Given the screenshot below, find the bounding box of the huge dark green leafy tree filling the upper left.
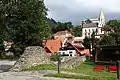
[0,0,51,57]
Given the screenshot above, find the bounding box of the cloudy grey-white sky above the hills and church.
[44,0,120,25]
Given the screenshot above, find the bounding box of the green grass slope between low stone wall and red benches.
[63,62,116,77]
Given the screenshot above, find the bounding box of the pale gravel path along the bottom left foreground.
[0,71,84,80]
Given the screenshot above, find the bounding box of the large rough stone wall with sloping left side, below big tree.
[10,46,51,71]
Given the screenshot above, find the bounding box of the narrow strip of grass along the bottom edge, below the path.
[44,74,116,80]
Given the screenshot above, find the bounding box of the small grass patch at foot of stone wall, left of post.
[26,64,56,71]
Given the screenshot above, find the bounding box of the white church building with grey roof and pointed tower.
[82,9,105,38]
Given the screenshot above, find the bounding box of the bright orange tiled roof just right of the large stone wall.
[45,40,61,53]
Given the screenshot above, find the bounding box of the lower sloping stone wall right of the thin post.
[61,56,86,69]
